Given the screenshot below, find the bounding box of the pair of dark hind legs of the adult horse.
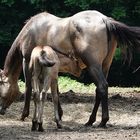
[86,64,109,127]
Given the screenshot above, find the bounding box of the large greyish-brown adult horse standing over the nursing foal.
[2,10,140,127]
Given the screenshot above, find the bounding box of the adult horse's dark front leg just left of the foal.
[21,58,32,121]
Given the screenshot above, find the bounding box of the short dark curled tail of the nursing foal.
[39,50,55,67]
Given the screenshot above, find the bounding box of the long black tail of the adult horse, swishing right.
[104,18,140,62]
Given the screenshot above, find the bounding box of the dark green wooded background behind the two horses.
[0,0,140,86]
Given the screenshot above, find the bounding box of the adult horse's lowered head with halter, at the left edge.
[0,69,18,115]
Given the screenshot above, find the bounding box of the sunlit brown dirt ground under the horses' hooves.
[0,91,140,140]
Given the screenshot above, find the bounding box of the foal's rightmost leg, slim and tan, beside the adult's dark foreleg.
[51,78,62,128]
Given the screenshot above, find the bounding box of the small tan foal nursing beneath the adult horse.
[29,46,84,131]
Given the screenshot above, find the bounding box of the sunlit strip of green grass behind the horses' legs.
[18,76,140,94]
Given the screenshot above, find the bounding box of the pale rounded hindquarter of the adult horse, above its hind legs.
[70,11,108,65]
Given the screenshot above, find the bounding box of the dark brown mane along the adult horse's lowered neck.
[4,12,47,75]
